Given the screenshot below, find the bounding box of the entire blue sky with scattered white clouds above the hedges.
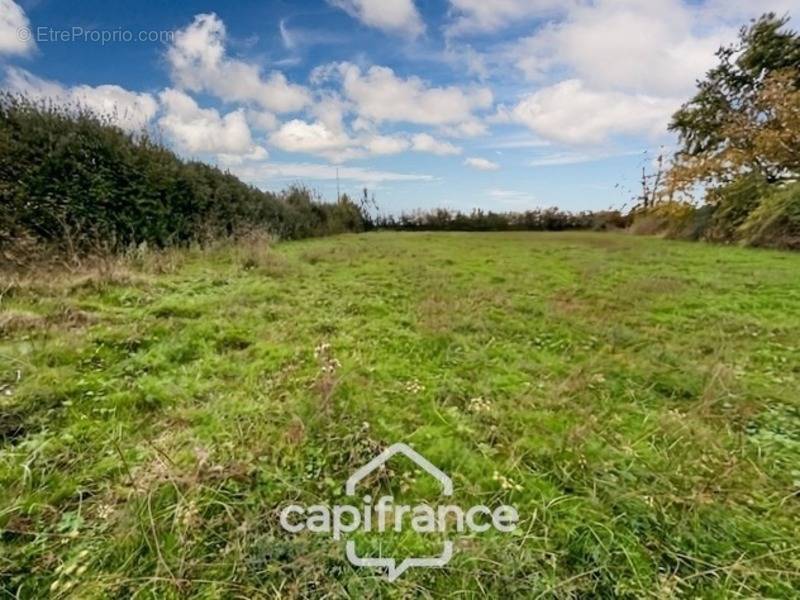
[0,0,800,212]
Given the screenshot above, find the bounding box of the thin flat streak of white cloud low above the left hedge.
[231,163,434,185]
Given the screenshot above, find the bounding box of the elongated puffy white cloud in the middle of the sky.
[332,63,493,126]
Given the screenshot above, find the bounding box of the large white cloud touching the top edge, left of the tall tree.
[510,0,736,95]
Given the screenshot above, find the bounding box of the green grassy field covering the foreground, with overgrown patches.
[0,233,800,598]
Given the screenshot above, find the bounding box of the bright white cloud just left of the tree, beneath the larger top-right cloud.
[507,79,681,144]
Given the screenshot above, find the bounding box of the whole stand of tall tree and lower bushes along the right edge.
[633,14,800,249]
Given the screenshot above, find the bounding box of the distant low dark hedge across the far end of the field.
[375,208,630,231]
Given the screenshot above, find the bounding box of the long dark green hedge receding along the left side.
[0,94,369,262]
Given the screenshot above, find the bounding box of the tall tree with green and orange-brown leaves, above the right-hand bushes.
[670,13,800,190]
